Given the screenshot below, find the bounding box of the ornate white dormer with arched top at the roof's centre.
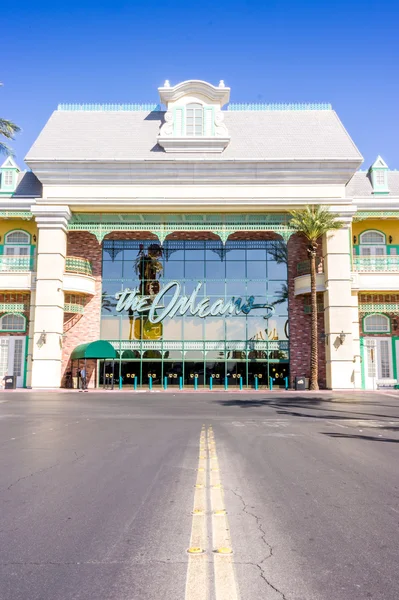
[158,79,230,152]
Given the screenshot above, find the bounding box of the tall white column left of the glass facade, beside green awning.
[31,205,71,388]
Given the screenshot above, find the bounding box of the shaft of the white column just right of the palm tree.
[323,227,358,390]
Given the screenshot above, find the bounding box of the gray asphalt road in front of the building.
[0,392,399,600]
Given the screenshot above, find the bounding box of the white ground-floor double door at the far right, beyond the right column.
[364,337,393,390]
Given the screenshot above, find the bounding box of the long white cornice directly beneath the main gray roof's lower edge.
[28,159,359,185]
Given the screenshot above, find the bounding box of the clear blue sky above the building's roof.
[0,0,399,169]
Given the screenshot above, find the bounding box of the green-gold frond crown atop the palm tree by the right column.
[289,205,344,243]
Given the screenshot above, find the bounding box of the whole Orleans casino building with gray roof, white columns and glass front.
[0,80,399,389]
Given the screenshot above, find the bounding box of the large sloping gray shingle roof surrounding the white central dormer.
[26,110,362,163]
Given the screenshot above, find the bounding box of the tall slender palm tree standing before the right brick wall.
[289,206,344,390]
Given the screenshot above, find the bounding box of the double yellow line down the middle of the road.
[185,425,239,600]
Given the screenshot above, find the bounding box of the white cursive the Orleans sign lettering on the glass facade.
[115,281,274,323]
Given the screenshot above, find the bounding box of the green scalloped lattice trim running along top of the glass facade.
[68,213,293,244]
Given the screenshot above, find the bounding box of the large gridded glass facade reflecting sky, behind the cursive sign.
[99,240,289,387]
